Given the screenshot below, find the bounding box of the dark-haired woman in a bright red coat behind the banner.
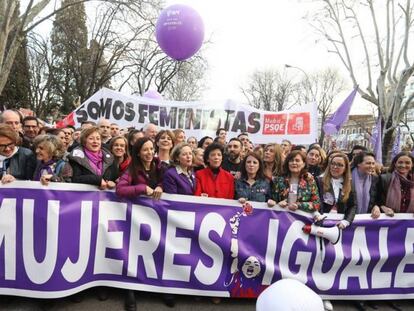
[194,143,234,199]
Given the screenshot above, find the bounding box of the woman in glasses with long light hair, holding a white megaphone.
[318,152,356,229]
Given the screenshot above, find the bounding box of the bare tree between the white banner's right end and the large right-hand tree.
[298,68,346,146]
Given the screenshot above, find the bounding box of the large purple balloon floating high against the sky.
[156,4,204,60]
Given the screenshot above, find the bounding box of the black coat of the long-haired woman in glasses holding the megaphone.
[317,177,357,223]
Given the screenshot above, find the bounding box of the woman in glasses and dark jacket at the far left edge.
[0,124,36,184]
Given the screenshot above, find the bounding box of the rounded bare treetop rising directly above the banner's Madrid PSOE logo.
[240,69,297,111]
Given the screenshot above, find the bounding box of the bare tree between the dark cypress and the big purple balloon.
[79,1,161,100]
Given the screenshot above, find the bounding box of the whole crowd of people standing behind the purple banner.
[0,110,414,310]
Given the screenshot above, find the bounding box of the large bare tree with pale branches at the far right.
[312,0,414,161]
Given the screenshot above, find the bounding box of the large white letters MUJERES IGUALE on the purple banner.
[0,198,414,290]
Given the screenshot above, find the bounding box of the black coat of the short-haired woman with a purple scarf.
[68,147,119,187]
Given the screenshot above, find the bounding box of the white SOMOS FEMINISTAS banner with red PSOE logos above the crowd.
[60,88,317,144]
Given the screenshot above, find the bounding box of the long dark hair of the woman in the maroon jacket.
[128,137,161,182]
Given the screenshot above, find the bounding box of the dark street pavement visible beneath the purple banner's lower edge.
[0,289,414,311]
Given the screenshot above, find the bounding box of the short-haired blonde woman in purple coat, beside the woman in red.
[162,143,196,195]
